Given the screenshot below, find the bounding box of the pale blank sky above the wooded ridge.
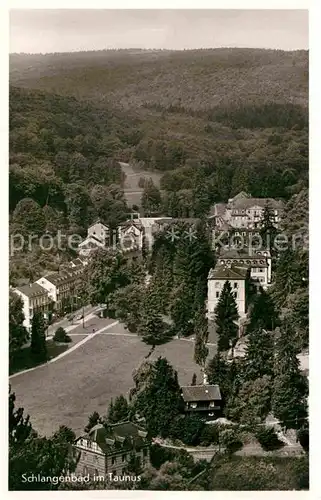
[10,9,308,53]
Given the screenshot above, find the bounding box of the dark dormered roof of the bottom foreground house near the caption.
[76,422,149,454]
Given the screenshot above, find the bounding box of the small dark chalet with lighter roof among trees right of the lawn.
[181,384,222,419]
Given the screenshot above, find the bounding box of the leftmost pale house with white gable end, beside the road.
[12,283,53,330]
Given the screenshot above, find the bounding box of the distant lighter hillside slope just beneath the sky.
[10,49,308,111]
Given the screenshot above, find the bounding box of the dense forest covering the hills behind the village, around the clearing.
[9,49,308,286]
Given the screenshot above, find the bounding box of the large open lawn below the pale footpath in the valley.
[10,325,213,435]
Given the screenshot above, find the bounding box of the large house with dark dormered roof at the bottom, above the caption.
[74,422,151,476]
